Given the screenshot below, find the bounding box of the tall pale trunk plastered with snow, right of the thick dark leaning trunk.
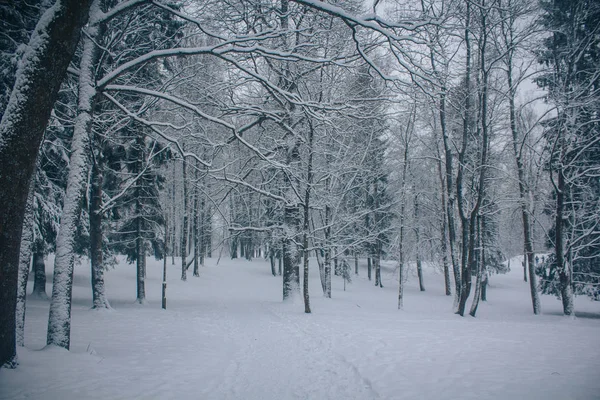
[47,0,99,349]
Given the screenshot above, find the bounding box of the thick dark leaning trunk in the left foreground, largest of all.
[0,0,91,367]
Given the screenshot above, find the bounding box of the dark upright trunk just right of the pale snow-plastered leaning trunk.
[89,154,110,309]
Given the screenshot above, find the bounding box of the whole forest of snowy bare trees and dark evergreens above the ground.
[0,0,600,382]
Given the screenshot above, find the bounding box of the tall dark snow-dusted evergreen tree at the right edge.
[537,0,600,315]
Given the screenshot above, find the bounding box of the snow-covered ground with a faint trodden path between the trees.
[0,255,600,400]
